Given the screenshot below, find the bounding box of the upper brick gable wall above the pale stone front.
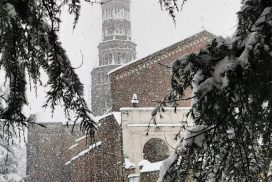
[110,31,214,111]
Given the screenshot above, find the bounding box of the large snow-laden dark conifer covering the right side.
[160,0,272,181]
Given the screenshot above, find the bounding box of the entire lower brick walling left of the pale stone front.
[25,115,125,182]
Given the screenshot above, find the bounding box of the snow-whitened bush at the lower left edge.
[0,86,26,182]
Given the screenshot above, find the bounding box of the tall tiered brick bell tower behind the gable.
[91,0,136,116]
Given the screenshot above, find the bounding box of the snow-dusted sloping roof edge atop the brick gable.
[108,30,214,75]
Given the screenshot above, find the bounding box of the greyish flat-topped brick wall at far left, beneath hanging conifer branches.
[25,123,81,182]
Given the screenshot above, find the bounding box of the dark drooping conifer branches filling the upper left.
[0,0,96,135]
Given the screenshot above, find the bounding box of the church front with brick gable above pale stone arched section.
[109,31,215,181]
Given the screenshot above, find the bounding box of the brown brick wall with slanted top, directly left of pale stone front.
[67,115,125,182]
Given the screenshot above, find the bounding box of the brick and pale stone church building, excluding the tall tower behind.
[26,30,214,182]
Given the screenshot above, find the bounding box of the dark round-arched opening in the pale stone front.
[143,138,169,163]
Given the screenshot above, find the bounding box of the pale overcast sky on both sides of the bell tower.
[29,0,241,113]
